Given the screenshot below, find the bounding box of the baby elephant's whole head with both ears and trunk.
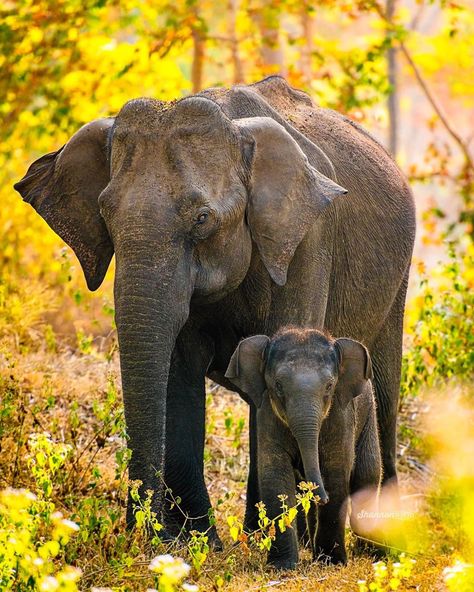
[226,328,372,504]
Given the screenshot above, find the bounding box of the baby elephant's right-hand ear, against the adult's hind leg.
[334,337,373,402]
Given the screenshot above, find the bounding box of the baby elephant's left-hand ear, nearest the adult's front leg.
[225,335,270,407]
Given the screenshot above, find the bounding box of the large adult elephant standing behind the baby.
[15,77,415,544]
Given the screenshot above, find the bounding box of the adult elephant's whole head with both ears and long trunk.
[15,97,346,512]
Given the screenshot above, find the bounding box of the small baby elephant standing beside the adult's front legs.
[226,328,381,569]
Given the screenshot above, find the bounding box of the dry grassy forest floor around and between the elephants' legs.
[0,347,466,592]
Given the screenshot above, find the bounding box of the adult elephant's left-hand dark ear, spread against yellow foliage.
[14,118,114,290]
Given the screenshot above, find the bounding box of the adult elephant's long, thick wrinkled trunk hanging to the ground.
[115,229,192,525]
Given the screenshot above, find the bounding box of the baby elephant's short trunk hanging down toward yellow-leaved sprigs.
[292,418,329,505]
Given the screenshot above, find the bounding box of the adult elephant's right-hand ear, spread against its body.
[233,117,347,286]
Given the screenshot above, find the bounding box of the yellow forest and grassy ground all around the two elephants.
[0,0,474,591]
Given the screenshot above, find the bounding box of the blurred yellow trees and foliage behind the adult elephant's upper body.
[0,0,474,328]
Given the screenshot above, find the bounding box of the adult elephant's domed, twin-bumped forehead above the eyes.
[112,98,241,180]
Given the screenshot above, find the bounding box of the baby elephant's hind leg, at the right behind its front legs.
[350,409,382,539]
